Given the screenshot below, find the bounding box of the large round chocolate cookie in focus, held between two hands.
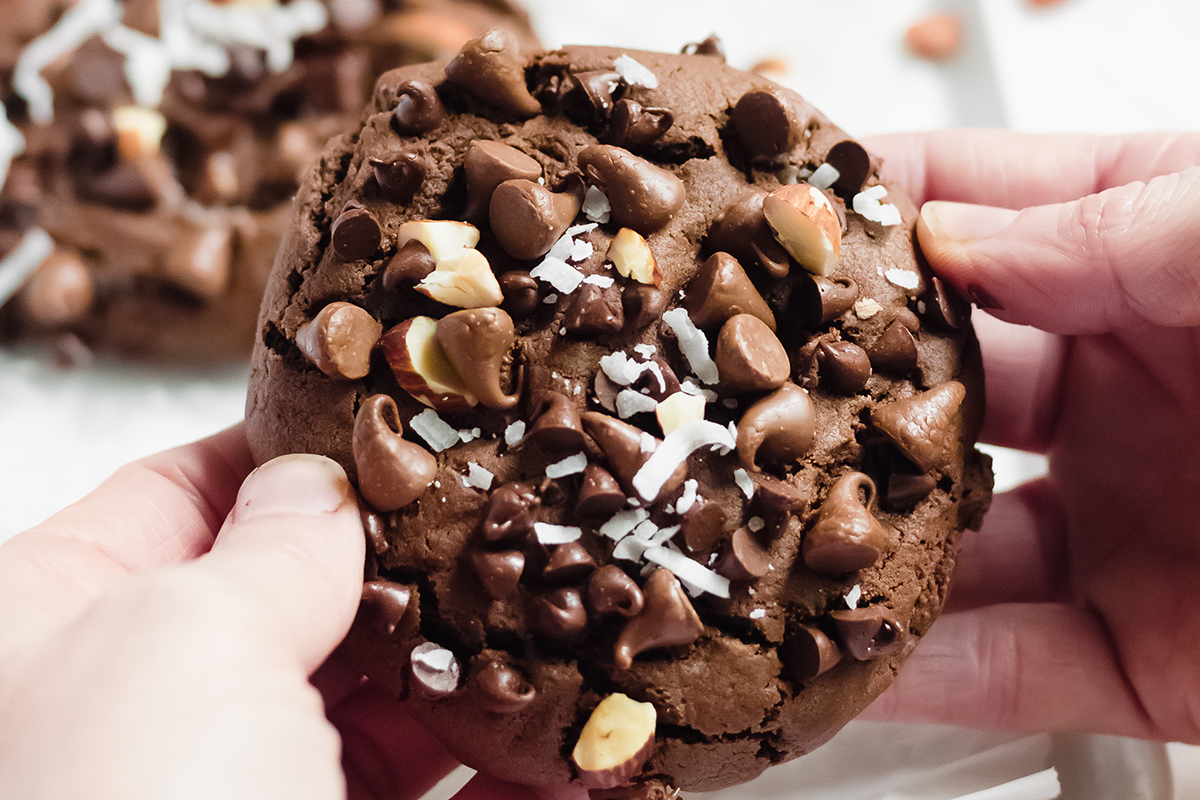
[247,34,991,796]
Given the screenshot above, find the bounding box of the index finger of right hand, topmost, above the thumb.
[863,130,1200,209]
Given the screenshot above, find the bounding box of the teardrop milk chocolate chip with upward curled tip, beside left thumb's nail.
[352,395,438,511]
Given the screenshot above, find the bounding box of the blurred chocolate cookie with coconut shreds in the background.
[0,0,534,361]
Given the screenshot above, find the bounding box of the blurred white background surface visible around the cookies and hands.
[0,0,1200,800]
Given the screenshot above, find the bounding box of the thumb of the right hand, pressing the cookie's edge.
[917,168,1200,333]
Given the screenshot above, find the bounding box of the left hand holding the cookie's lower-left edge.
[0,426,583,800]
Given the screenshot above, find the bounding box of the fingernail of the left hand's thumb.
[233,453,352,522]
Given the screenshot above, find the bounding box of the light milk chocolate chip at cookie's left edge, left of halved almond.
[295,301,383,380]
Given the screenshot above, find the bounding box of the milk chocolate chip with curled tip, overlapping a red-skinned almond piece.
[434,308,521,410]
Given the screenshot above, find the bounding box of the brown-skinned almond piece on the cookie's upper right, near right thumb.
[762,184,841,276]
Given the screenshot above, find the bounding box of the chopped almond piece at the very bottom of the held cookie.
[571,692,658,789]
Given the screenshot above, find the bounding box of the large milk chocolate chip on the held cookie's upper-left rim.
[445,28,541,118]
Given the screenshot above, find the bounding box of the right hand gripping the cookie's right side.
[866,131,1200,742]
